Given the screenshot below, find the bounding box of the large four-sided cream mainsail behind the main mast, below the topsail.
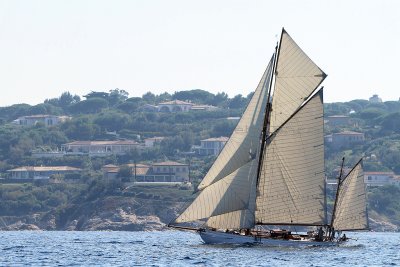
[256,90,325,225]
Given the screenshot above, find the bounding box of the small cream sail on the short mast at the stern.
[333,161,368,230]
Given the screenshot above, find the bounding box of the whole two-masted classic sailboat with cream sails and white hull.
[169,29,368,245]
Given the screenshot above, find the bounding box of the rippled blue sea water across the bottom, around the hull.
[0,230,400,266]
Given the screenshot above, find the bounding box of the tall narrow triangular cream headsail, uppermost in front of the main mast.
[198,55,273,190]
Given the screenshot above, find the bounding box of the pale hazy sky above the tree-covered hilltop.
[0,0,400,106]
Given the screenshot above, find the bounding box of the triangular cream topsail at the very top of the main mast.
[270,30,326,132]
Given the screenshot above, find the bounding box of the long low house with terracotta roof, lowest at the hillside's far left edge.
[7,166,82,179]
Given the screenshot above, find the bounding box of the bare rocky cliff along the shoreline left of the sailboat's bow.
[0,197,182,231]
